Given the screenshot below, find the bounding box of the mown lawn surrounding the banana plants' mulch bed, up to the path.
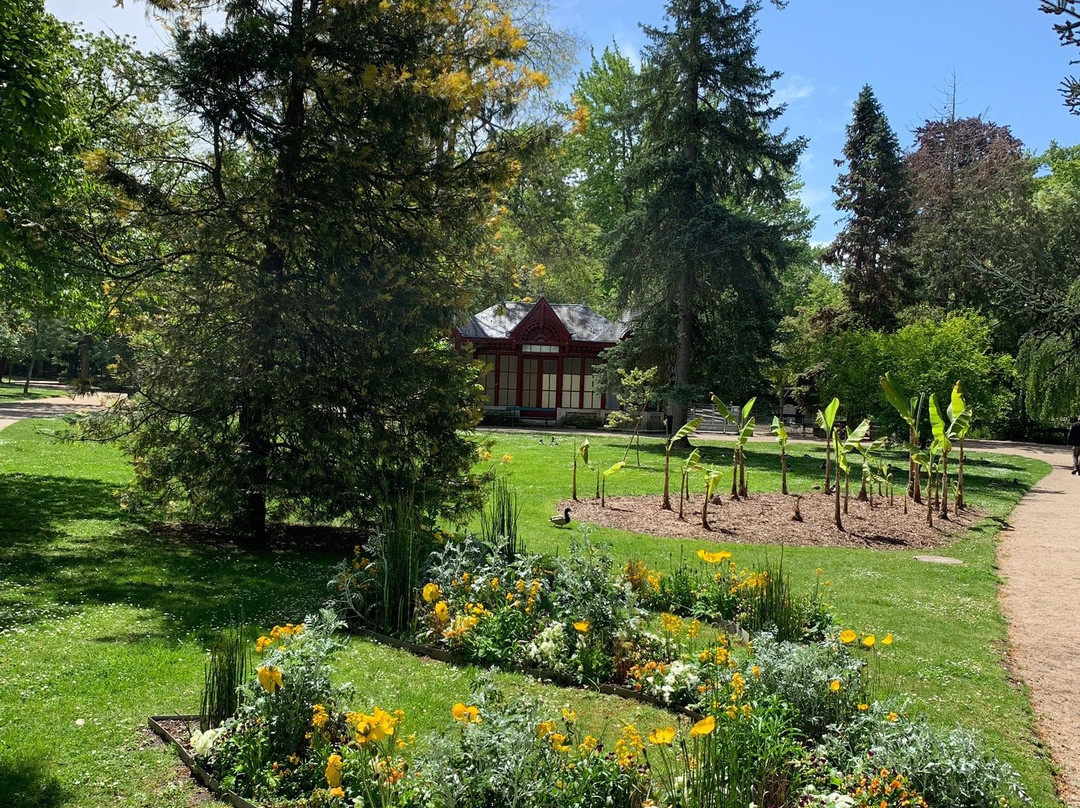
[477,432,1057,805]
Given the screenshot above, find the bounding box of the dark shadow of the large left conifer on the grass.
[0,474,360,639]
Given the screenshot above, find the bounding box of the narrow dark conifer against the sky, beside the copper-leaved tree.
[823,85,914,329]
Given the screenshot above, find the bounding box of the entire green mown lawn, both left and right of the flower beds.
[0,421,1056,808]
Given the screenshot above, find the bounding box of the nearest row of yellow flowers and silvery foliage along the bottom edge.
[172,613,1026,808]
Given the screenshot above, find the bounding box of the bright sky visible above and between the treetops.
[45,0,1080,242]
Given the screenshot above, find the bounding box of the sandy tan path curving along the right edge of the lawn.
[968,441,1080,808]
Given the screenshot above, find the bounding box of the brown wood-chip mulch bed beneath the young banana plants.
[558,491,983,550]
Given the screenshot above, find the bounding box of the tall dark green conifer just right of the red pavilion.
[610,0,804,429]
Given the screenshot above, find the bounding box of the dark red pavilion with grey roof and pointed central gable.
[455,297,630,425]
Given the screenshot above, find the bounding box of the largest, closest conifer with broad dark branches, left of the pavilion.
[82,0,545,537]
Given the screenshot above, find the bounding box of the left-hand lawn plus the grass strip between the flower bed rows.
[0,421,670,808]
